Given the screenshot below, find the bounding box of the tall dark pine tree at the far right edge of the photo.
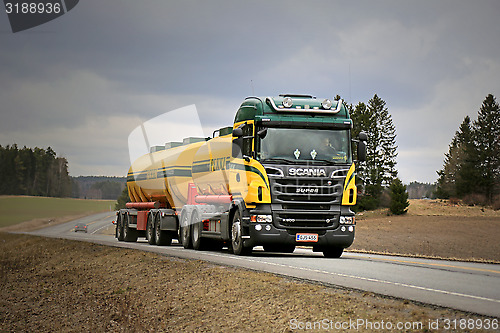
[474,94,500,203]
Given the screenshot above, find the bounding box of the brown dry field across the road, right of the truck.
[350,200,500,263]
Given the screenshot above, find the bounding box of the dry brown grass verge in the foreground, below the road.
[0,233,492,332]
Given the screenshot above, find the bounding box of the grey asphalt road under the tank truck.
[31,212,500,318]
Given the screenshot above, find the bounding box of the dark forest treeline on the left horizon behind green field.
[0,144,126,200]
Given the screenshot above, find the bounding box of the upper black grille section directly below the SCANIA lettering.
[270,177,342,205]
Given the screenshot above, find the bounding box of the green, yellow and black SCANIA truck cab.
[232,95,364,257]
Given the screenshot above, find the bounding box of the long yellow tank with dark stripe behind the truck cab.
[127,135,231,208]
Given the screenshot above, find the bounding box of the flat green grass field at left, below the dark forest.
[0,196,115,228]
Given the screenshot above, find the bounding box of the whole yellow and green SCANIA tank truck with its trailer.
[116,95,366,258]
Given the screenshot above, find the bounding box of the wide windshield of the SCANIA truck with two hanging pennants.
[257,128,352,164]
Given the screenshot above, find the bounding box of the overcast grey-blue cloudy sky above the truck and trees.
[0,0,500,183]
